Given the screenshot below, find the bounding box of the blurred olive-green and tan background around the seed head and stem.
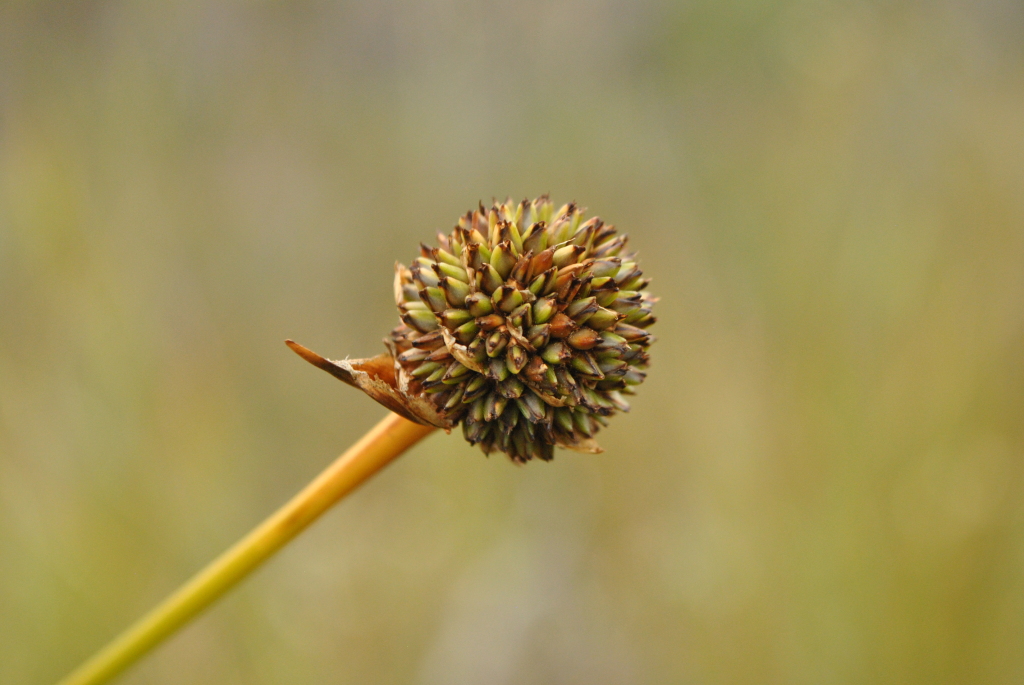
[0,0,1024,685]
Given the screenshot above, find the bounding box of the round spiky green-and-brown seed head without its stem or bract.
[388,196,655,462]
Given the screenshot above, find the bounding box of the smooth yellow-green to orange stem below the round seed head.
[58,414,434,685]
